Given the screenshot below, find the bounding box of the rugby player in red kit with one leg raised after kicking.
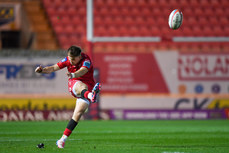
[35,46,101,148]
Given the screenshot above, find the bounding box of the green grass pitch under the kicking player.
[0,120,229,153]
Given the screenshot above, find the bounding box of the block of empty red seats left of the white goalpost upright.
[43,0,86,49]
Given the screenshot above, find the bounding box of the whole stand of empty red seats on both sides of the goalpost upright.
[43,0,229,51]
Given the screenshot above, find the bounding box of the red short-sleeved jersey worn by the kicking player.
[57,53,95,91]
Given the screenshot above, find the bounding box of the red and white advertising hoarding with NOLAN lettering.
[95,51,229,94]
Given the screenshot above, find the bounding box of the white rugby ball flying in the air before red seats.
[168,9,183,30]
